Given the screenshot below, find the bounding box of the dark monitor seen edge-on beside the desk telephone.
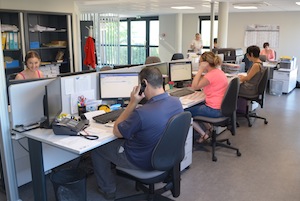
[41,77,62,128]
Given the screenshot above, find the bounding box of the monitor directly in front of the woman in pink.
[169,61,192,88]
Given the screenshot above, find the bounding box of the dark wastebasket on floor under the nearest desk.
[50,169,86,201]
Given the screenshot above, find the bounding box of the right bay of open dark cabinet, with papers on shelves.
[24,13,73,74]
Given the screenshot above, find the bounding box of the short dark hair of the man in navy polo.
[139,66,163,88]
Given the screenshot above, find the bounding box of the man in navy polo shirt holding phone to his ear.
[92,67,183,199]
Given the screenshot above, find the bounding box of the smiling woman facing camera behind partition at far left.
[15,51,44,80]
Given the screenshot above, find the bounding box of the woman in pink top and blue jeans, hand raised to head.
[186,52,228,143]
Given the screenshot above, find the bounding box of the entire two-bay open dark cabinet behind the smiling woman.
[0,10,74,77]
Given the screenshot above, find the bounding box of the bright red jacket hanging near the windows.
[83,36,96,68]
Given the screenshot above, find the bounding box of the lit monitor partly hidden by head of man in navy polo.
[99,71,139,100]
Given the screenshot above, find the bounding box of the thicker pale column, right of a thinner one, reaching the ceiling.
[218,2,229,48]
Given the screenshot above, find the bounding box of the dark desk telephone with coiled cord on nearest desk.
[52,118,86,135]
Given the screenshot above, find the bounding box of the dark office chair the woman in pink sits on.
[193,77,241,162]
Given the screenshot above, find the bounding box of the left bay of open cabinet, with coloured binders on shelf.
[0,10,24,76]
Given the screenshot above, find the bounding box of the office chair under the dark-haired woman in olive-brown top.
[239,68,269,127]
